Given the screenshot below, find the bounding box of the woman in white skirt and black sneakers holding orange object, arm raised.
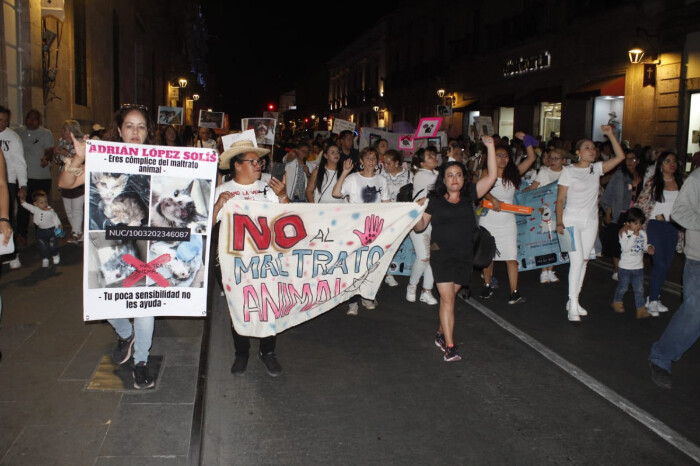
[479,131,539,304]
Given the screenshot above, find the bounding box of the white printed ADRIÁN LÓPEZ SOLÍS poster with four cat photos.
[83,140,217,320]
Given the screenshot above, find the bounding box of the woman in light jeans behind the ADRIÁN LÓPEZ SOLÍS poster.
[58,104,155,389]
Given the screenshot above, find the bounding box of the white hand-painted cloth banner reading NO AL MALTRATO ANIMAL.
[219,200,424,337]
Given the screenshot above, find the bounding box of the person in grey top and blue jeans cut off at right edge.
[649,170,700,388]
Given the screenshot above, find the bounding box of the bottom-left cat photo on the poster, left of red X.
[86,232,146,289]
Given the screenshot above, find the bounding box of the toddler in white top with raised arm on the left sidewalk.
[18,190,63,268]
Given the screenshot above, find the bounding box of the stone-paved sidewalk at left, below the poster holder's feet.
[0,244,203,465]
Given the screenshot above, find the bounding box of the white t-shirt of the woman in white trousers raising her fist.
[559,162,603,218]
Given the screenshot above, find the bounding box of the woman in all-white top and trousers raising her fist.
[556,125,625,322]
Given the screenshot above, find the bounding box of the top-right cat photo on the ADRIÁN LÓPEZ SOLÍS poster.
[150,176,211,234]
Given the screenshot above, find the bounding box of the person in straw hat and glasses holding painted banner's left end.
[212,139,289,377]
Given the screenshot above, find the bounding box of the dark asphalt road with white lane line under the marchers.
[202,255,700,464]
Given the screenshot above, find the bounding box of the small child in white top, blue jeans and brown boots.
[612,207,654,319]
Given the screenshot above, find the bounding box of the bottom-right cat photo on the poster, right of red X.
[148,235,206,288]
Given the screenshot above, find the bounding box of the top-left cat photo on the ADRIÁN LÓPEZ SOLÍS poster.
[89,172,151,230]
